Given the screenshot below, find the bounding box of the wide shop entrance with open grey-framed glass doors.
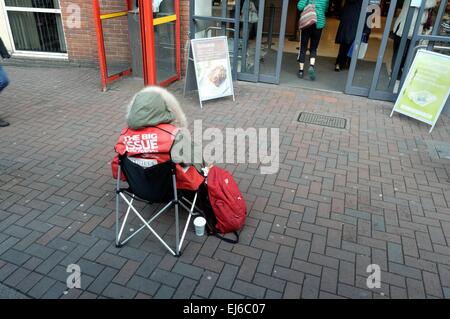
[190,0,450,101]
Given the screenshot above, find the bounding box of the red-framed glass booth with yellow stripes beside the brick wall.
[93,0,181,90]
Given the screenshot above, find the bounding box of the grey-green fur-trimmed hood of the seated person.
[126,86,187,129]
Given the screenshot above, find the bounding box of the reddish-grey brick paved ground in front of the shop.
[0,67,450,298]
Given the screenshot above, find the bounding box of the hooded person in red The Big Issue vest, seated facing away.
[112,86,204,190]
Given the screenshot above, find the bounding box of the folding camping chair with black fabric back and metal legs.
[116,155,198,257]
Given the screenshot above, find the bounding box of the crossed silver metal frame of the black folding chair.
[115,163,199,257]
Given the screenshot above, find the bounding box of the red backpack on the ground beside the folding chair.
[200,166,247,243]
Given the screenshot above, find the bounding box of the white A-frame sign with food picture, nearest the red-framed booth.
[191,36,234,107]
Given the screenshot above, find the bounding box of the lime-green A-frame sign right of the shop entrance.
[391,50,450,132]
